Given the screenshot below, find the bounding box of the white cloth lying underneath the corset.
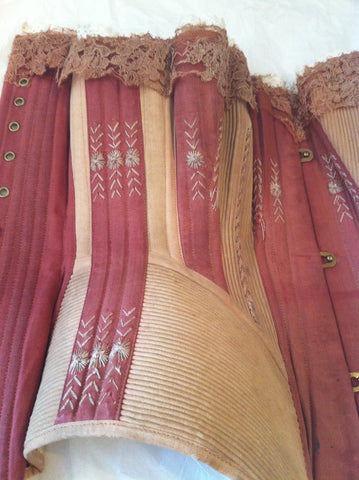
[0,0,359,480]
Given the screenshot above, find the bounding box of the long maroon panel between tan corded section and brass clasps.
[252,89,359,480]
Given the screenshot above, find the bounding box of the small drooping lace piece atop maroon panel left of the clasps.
[252,76,305,142]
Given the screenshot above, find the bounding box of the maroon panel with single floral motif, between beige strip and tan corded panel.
[174,32,227,290]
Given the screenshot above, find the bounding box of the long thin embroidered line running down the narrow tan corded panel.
[234,129,259,323]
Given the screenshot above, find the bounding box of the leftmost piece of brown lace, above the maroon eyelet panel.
[5,31,76,85]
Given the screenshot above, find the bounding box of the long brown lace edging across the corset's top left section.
[5,25,255,107]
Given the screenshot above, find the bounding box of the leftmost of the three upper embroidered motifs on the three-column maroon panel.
[90,123,105,201]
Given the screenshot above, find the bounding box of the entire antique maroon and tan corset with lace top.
[0,26,359,480]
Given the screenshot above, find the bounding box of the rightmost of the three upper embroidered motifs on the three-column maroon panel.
[125,120,142,197]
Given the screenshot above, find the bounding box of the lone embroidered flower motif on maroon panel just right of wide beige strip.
[184,117,206,200]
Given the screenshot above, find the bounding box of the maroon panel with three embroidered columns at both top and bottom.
[56,77,148,423]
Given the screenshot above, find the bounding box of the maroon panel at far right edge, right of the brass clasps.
[303,119,359,412]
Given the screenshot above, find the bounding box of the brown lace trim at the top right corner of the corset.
[297,52,359,117]
